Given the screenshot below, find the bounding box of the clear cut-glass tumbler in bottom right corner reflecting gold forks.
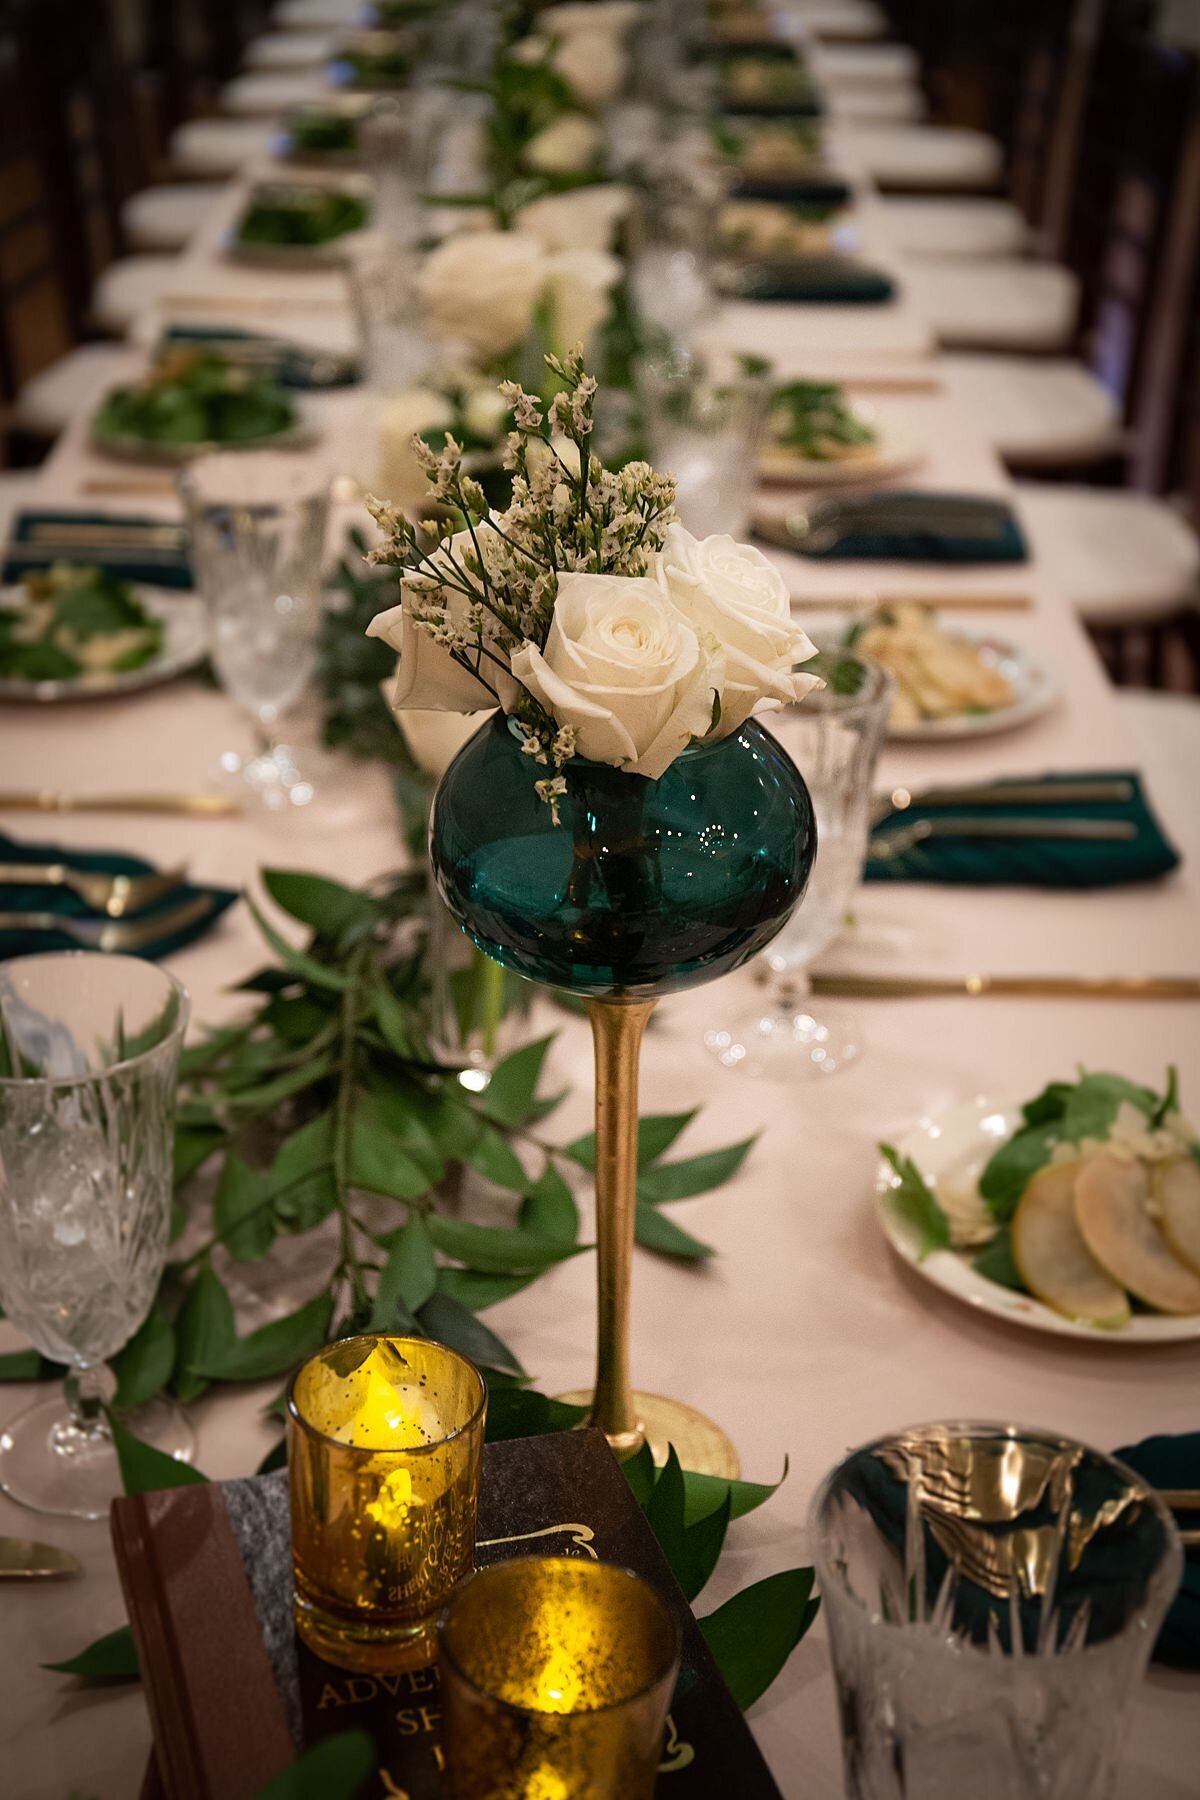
[810,1424,1182,1800]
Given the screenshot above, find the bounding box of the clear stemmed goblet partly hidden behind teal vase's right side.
[703,644,892,1080]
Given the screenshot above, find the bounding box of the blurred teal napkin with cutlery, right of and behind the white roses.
[792,490,1029,563]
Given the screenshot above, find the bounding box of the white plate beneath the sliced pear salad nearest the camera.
[874,1094,1200,1346]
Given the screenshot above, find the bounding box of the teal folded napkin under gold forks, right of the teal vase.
[865,769,1178,887]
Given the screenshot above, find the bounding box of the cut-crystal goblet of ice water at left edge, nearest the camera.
[0,950,194,1519]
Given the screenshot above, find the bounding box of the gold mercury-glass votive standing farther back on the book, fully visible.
[288,1334,488,1672]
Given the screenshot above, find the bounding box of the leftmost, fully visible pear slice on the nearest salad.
[1013,1163,1130,1330]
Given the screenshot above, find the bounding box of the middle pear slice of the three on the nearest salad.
[1076,1152,1200,1312]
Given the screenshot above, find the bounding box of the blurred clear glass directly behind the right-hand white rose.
[639,353,770,538]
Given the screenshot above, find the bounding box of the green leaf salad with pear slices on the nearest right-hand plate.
[880,1069,1200,1330]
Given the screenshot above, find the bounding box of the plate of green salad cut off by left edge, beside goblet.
[0,583,209,702]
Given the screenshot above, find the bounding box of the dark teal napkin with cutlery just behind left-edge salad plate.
[0,509,193,587]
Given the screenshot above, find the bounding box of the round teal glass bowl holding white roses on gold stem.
[430,715,817,1001]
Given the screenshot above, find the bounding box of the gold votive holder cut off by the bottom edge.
[437,1557,680,1800]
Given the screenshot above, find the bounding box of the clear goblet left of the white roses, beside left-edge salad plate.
[182,450,329,810]
